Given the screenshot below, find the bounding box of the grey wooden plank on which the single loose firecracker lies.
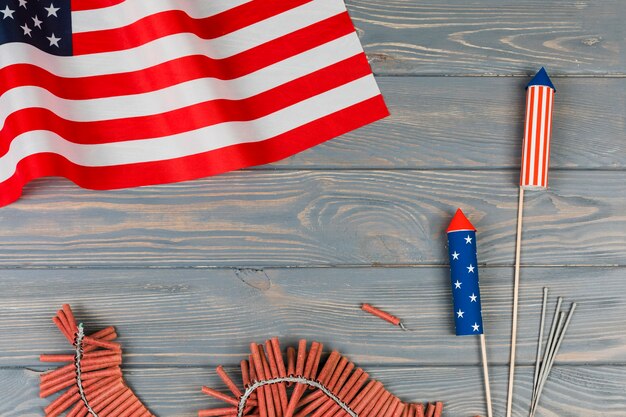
[0,267,626,366]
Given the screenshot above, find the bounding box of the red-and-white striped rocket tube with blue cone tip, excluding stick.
[520,68,556,189]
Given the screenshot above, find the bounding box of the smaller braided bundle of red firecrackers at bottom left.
[39,304,152,417]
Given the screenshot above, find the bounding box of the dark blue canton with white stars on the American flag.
[0,0,72,55]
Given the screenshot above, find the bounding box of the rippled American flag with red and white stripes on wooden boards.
[0,0,388,206]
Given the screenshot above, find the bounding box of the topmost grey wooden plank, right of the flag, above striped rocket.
[347,0,626,75]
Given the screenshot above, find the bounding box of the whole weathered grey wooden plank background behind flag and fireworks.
[0,0,626,417]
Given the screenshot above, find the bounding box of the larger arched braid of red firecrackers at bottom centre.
[198,338,443,417]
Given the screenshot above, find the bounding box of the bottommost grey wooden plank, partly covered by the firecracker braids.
[0,366,626,417]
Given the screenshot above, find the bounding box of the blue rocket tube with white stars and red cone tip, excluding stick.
[447,209,483,336]
